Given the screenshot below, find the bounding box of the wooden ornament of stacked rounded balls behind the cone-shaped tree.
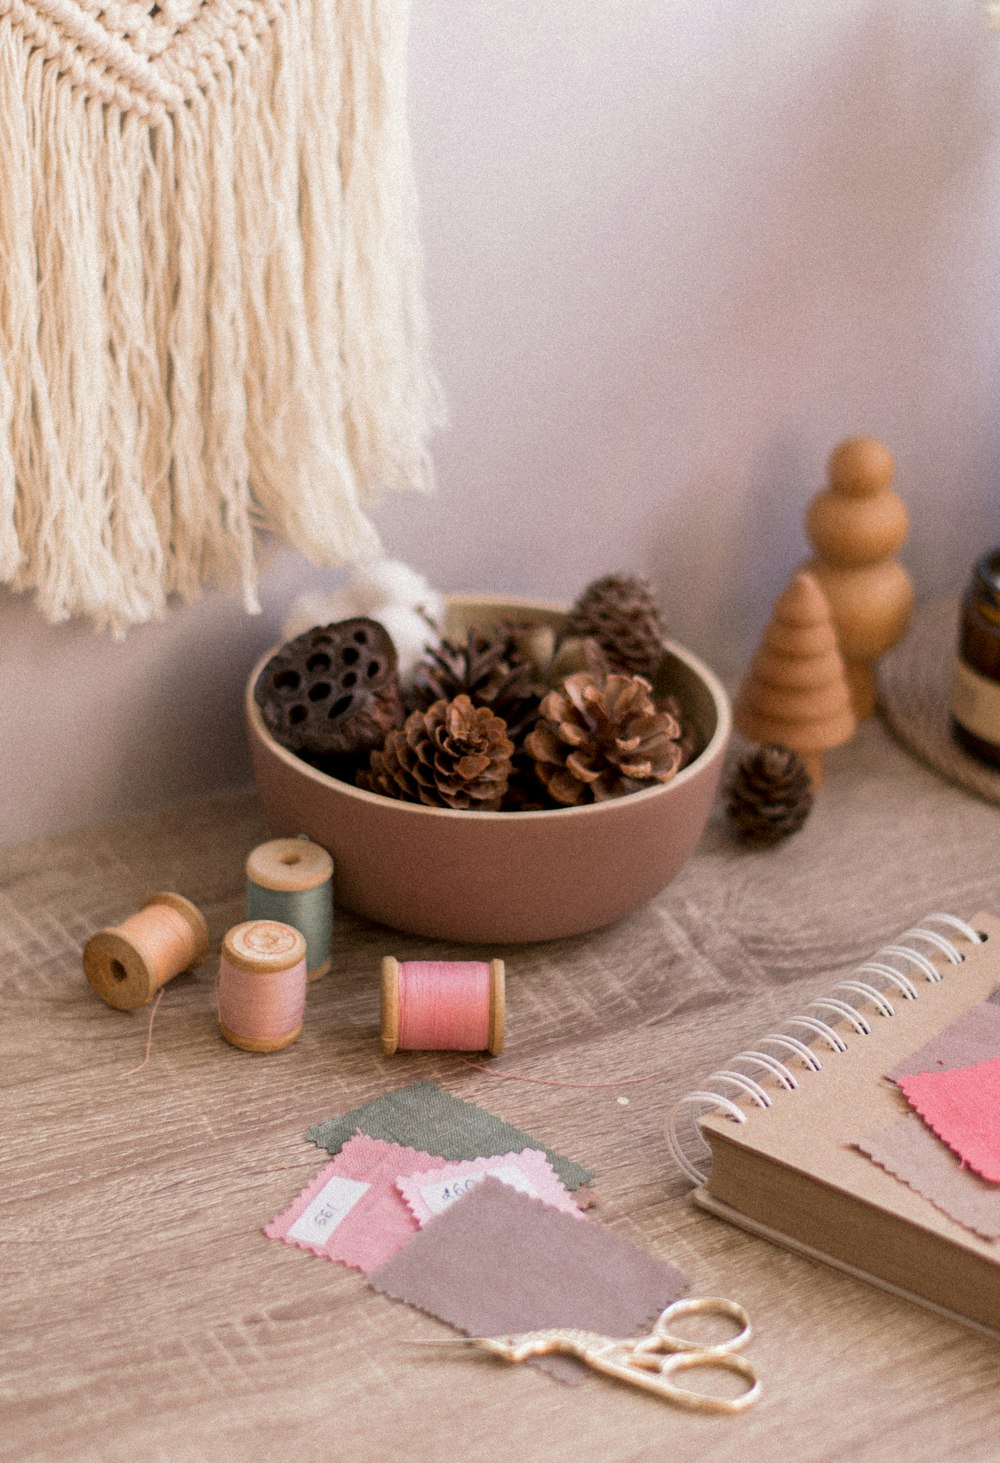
[804,437,914,720]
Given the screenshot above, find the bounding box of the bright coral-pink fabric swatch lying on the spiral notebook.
[899,1056,1000,1184]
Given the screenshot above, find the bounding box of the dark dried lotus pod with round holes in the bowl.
[253,617,404,761]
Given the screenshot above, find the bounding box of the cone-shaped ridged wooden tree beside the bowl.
[735,572,855,787]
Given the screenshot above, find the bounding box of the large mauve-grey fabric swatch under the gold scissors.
[368,1178,687,1383]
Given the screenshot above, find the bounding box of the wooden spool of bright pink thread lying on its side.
[382,955,504,1056]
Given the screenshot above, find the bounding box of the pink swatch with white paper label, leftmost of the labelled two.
[265,1132,443,1274]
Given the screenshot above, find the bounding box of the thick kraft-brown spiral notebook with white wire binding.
[667,914,1000,1337]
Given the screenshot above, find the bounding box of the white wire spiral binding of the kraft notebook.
[667,911,984,1184]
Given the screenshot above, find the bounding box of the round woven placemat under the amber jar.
[876,595,1000,803]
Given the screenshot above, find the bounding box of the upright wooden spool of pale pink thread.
[218,919,308,1052]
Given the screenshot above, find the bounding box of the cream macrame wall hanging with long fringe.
[0,0,439,629]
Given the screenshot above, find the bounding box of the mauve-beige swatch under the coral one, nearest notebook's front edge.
[855,1112,1000,1239]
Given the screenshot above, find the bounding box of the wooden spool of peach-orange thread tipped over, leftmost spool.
[83,894,209,1011]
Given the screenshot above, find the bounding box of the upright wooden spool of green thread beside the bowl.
[247,835,333,980]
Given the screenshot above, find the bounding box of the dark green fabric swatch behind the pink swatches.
[306,1083,594,1189]
